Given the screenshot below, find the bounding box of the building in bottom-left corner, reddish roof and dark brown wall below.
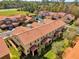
[0,37,10,59]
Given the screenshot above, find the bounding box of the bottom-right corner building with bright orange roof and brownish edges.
[63,37,79,59]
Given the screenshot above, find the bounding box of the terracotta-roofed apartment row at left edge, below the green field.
[0,15,32,30]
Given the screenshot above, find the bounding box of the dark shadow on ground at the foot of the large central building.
[21,43,52,59]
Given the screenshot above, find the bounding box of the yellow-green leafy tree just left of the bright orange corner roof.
[52,39,69,59]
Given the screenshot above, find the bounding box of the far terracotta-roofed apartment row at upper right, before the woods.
[41,11,75,24]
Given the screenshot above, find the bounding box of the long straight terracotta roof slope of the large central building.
[14,20,65,45]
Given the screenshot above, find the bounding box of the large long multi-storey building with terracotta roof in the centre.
[11,19,65,56]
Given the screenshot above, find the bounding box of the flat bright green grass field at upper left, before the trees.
[0,9,33,16]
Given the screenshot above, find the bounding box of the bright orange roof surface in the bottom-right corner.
[64,37,79,59]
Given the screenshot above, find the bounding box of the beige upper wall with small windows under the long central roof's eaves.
[12,26,64,55]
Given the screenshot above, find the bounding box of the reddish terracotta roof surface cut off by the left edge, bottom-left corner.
[0,37,9,58]
